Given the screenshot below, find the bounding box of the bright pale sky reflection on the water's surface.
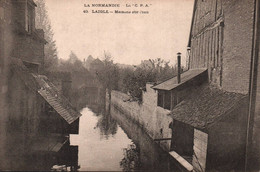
[71,108,131,171]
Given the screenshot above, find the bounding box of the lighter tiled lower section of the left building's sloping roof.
[33,74,81,124]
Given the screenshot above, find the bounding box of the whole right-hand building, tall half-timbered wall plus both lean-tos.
[147,0,259,171]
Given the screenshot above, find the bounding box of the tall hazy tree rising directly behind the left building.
[35,0,58,70]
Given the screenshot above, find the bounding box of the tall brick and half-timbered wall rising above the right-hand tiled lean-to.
[190,0,254,94]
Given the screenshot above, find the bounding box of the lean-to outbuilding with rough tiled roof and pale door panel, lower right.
[171,83,247,171]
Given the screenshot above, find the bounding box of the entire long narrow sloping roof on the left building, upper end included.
[10,58,81,124]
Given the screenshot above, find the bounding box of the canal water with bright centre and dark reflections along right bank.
[70,89,179,171]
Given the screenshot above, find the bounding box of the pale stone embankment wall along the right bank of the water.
[111,84,172,151]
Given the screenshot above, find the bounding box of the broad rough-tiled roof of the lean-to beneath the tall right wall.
[170,84,247,129]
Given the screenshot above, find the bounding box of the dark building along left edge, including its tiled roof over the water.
[0,0,81,170]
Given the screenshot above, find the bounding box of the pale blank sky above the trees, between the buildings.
[46,0,194,64]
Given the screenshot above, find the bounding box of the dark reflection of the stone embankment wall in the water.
[111,103,180,171]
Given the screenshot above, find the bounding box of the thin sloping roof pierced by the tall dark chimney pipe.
[152,68,207,91]
